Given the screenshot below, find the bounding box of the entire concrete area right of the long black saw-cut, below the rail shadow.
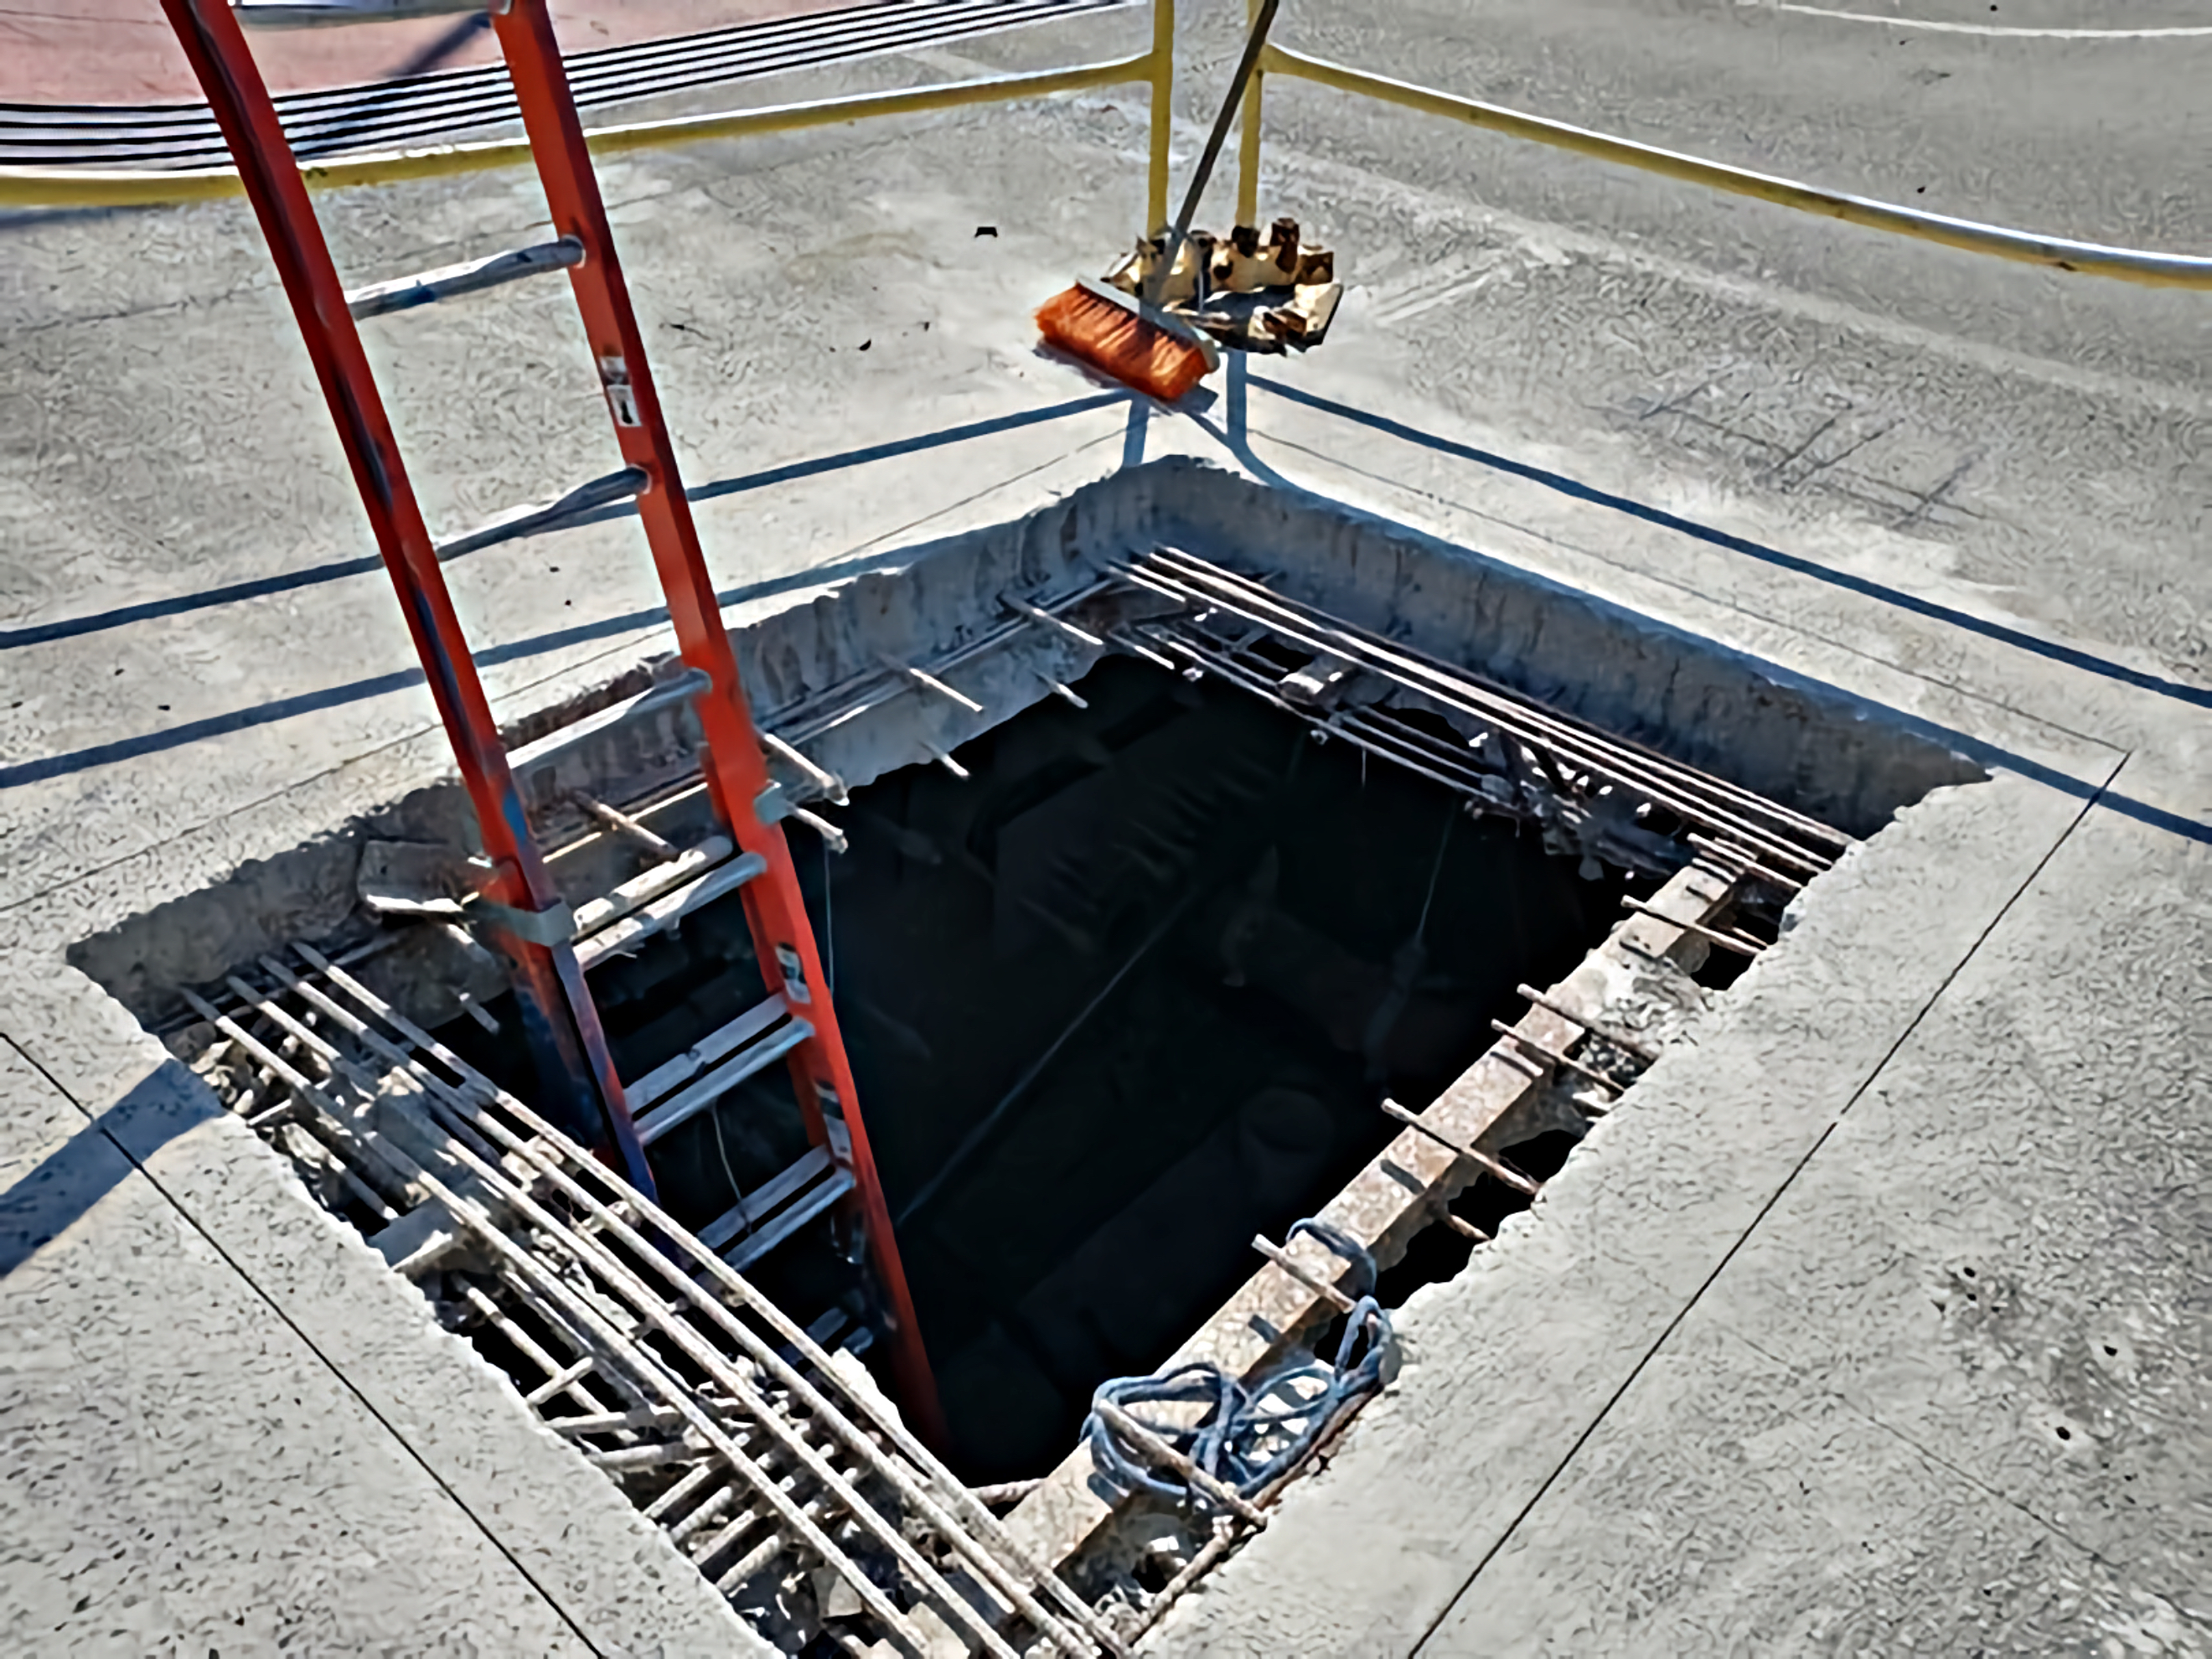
[1415,787,2212,1652]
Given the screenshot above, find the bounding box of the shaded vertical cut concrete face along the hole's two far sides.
[69,456,1987,1024]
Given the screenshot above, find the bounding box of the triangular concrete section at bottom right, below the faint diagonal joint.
[1424,1323,2208,1659]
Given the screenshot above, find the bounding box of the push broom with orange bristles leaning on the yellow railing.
[1037,0,1281,402]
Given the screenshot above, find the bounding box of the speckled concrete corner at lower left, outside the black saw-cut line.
[0,1044,604,1655]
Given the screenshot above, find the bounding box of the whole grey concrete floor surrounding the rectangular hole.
[0,0,2212,1655]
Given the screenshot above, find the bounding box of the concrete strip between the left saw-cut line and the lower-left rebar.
[0,962,774,1659]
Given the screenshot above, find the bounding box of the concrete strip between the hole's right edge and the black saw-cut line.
[1132,777,2150,1655]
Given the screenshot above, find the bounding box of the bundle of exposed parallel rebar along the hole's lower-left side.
[201,947,1121,1659]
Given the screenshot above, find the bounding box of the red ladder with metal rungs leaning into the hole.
[162,0,943,1445]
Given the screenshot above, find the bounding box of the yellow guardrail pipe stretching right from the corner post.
[1258,46,2212,290]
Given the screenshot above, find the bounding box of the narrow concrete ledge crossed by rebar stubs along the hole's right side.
[1006,863,1736,1573]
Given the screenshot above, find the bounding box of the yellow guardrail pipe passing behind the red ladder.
[0,51,1159,208]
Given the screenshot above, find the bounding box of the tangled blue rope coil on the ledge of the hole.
[1084,1217,1398,1508]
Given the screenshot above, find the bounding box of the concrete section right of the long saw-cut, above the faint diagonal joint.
[1663,774,2212,1632]
